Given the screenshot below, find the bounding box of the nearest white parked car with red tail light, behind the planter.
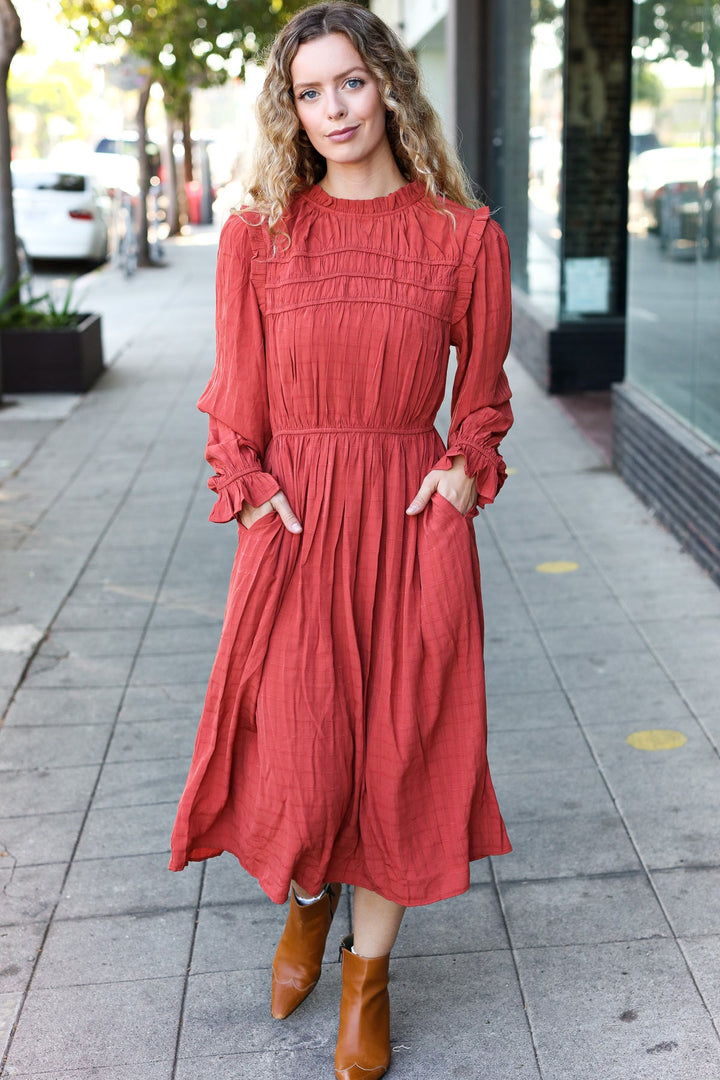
[11,161,110,262]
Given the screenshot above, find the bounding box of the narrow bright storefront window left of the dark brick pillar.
[528,0,565,318]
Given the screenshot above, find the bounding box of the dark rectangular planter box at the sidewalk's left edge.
[0,314,105,394]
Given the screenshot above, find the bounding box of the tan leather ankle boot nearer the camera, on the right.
[335,934,391,1080]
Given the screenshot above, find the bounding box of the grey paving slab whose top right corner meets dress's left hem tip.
[57,852,202,919]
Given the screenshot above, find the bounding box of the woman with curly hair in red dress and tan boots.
[171,2,512,1080]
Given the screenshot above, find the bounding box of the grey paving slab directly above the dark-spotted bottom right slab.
[500,873,671,948]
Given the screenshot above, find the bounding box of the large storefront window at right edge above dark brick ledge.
[627,0,720,444]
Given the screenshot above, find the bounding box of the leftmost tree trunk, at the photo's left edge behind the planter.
[0,0,23,304]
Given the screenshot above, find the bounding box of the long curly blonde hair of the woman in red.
[248,0,479,231]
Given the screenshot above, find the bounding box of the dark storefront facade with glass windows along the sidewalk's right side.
[451,0,720,581]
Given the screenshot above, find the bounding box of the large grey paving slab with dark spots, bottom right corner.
[517,939,720,1080]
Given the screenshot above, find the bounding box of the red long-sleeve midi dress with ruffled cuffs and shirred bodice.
[171,181,513,905]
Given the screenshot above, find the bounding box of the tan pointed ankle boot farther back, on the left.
[270,882,342,1020]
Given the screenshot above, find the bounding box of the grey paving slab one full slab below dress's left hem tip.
[32,907,195,989]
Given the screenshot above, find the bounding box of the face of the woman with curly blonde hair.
[290,33,390,172]
